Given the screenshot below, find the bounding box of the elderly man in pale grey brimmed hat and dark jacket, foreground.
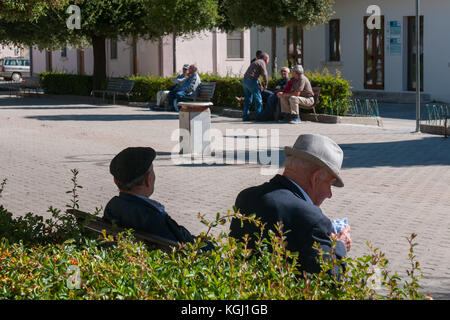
[230,134,351,273]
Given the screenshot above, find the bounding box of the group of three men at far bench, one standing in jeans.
[238,51,314,124]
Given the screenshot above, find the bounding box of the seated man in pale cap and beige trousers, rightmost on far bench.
[277,65,314,124]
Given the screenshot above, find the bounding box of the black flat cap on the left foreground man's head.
[109,147,156,183]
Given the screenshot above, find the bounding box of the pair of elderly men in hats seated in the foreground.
[103,134,351,272]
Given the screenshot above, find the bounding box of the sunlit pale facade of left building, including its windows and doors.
[32,30,251,77]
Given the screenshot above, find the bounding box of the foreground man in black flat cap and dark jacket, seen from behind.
[103,147,199,243]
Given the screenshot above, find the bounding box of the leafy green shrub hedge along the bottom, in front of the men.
[0,172,423,299]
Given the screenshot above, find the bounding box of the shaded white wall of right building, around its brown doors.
[251,0,450,102]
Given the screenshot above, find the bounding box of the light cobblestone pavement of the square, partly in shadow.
[0,95,450,299]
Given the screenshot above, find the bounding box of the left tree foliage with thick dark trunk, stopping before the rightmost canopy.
[0,0,217,88]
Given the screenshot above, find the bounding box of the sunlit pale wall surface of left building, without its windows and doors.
[28,30,253,81]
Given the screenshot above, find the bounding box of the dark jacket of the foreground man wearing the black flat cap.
[103,192,195,242]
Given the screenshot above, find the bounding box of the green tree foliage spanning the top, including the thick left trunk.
[0,0,334,84]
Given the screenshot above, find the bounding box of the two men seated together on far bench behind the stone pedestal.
[156,64,201,111]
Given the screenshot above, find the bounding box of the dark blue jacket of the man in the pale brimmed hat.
[230,175,347,273]
